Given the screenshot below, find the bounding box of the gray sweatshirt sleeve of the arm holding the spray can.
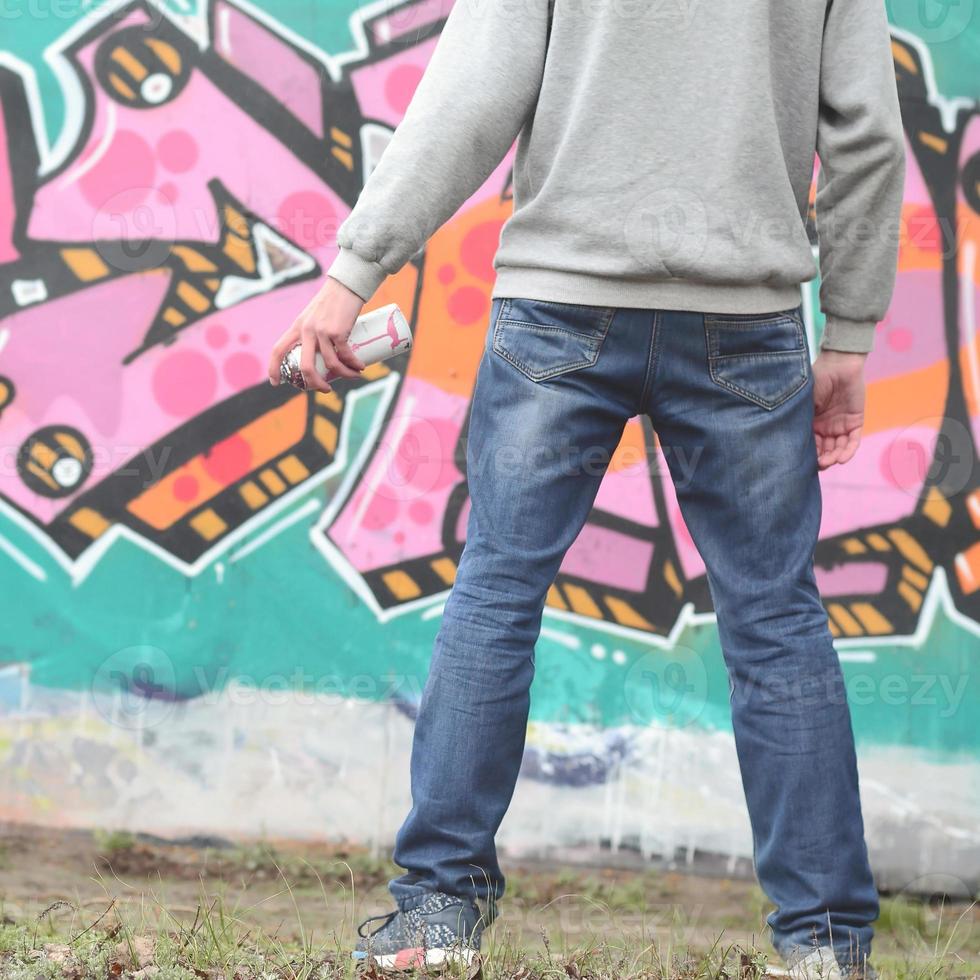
[327,0,548,302]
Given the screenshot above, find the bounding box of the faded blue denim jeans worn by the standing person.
[389,298,878,965]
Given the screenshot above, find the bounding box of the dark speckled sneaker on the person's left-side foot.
[351,892,486,970]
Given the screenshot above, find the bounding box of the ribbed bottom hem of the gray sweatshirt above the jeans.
[490,266,802,313]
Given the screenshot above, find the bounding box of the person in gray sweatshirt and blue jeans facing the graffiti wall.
[269,0,905,978]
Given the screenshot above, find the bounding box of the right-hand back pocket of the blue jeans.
[704,308,810,411]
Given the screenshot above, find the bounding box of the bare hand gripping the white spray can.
[269,276,366,391]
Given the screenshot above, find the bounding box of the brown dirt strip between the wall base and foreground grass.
[0,824,980,977]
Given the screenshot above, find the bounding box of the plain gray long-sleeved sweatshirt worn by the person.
[327,0,905,351]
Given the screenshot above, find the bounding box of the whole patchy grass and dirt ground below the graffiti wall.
[0,833,980,980]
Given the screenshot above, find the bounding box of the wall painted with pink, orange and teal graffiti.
[0,0,980,885]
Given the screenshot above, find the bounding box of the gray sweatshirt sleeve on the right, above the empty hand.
[815,0,905,352]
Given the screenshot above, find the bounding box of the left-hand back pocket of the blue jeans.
[493,298,616,381]
